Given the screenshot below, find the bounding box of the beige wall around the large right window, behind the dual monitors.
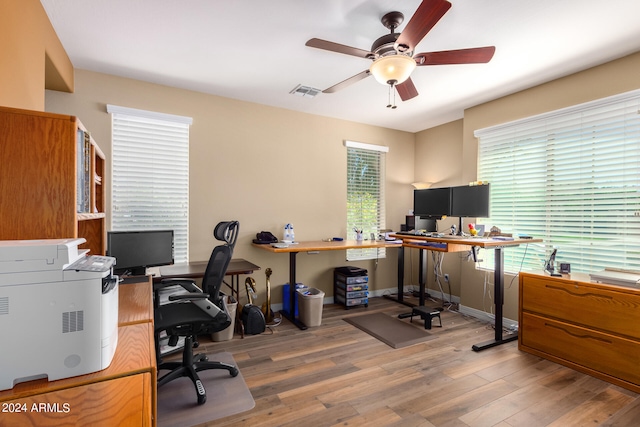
[415,52,640,320]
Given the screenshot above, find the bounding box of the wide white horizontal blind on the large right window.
[476,91,640,272]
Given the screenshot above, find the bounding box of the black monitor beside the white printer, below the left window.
[107,230,173,276]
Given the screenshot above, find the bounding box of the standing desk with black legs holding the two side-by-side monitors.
[392,234,542,351]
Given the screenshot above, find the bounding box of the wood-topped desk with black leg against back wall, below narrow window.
[252,240,402,329]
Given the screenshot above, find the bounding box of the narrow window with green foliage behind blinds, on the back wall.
[345,141,389,261]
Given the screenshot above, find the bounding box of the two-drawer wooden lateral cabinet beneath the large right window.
[518,273,640,393]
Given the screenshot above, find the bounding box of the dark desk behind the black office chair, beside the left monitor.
[158,258,260,301]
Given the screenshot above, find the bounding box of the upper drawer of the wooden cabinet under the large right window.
[520,274,640,339]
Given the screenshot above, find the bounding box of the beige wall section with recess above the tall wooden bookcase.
[0,0,73,111]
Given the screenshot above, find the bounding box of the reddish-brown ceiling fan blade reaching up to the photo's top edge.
[395,0,451,52]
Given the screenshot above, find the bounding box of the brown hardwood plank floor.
[172,298,640,427]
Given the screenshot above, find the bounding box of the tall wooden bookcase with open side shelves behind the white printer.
[0,107,106,255]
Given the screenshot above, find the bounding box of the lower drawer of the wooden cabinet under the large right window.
[520,313,640,385]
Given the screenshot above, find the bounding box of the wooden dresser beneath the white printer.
[0,277,157,426]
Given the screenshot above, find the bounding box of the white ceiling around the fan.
[41,0,640,132]
